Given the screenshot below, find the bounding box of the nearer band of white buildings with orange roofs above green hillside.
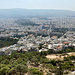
[0,31,75,55]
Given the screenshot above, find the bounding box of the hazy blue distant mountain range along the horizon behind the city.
[0,9,75,18]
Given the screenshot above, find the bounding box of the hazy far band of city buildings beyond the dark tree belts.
[0,17,75,37]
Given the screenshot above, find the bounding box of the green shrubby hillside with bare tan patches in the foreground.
[0,50,75,75]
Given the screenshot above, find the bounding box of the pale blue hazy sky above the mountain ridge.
[0,0,75,11]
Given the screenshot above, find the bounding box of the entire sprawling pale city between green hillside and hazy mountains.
[0,17,75,55]
